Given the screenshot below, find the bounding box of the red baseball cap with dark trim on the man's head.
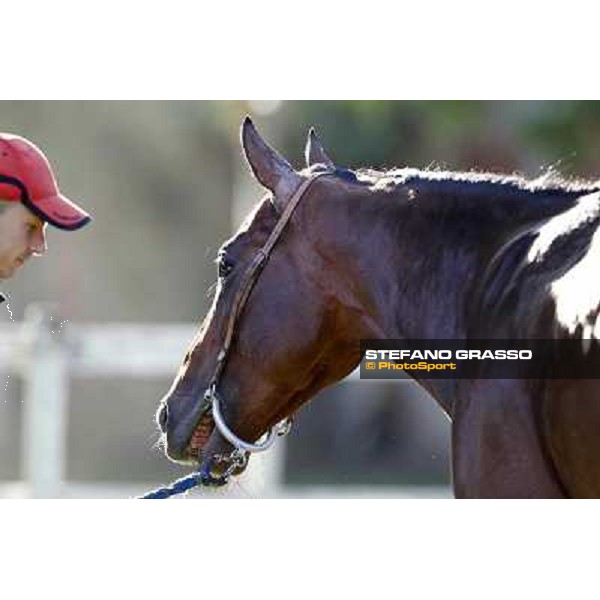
[0,133,91,231]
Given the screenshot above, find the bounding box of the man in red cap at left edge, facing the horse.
[0,133,91,302]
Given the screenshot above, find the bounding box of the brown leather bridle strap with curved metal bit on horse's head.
[203,170,331,468]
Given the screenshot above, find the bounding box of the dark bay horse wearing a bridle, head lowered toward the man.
[157,118,600,498]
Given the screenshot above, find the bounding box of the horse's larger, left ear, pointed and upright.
[242,117,302,202]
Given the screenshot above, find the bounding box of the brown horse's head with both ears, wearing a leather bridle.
[157,118,378,481]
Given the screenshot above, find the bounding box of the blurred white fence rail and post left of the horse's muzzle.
[0,305,382,498]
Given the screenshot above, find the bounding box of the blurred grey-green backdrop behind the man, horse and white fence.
[0,101,600,497]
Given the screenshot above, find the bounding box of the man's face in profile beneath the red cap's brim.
[0,202,47,279]
